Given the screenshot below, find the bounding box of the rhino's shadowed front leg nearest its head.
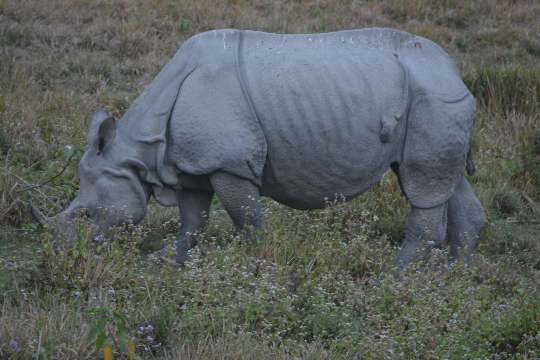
[175,188,213,264]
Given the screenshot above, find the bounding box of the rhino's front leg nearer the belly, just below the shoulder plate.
[210,172,262,241]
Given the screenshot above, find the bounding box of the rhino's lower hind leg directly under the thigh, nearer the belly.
[396,203,447,271]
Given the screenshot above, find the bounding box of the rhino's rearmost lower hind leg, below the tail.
[447,177,486,263]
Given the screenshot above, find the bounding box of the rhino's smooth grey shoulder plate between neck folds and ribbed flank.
[169,30,266,184]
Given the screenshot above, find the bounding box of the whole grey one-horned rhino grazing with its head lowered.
[30,28,485,269]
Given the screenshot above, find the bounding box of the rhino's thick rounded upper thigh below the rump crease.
[399,96,474,209]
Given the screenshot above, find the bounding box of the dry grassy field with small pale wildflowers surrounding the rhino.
[0,0,540,359]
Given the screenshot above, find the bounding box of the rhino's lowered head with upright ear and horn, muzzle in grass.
[31,111,150,240]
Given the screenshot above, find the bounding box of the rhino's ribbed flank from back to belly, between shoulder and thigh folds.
[240,31,406,208]
